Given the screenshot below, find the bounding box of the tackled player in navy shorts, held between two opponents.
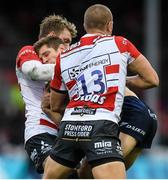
[34,34,157,179]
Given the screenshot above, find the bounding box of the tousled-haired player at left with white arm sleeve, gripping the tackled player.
[16,15,76,173]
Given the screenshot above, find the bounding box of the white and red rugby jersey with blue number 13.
[50,34,140,123]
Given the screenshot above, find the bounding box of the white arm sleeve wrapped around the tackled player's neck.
[21,60,55,81]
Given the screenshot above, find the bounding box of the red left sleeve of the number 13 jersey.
[50,55,62,90]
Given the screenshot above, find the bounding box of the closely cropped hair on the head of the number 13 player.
[84,4,113,30]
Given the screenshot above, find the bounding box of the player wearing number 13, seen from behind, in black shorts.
[43,5,158,179]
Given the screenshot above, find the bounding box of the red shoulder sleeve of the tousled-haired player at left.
[16,46,41,68]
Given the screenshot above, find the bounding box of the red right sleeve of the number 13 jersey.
[114,36,141,59]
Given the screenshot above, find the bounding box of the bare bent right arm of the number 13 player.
[126,54,159,89]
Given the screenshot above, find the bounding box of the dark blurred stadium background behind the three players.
[0,0,168,179]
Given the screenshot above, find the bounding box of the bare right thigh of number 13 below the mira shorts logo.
[92,161,126,179]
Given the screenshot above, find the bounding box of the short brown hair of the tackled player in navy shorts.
[33,36,64,54]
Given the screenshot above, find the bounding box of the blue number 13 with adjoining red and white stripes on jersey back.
[77,64,119,96]
